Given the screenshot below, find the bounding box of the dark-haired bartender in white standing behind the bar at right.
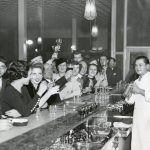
[126,56,150,150]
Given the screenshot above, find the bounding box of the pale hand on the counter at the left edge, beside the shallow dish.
[0,119,12,131]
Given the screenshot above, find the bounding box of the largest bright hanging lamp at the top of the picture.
[84,0,97,20]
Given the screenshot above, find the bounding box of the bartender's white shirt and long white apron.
[130,72,150,150]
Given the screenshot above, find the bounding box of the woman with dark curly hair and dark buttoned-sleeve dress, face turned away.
[2,61,58,116]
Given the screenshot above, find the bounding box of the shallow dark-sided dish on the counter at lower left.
[11,118,28,126]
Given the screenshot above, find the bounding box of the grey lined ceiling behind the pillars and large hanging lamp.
[0,0,112,35]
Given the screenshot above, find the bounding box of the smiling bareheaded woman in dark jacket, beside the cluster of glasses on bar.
[82,64,97,93]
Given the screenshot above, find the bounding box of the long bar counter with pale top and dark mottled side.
[0,90,131,150]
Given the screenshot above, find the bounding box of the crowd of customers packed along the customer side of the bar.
[0,52,121,120]
